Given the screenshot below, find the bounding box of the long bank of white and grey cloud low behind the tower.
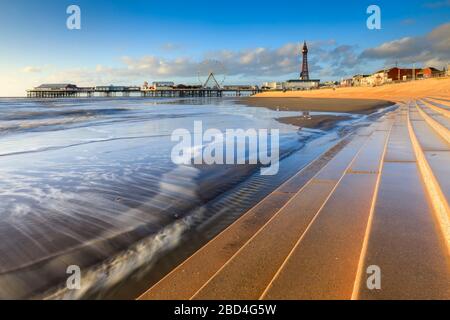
[23,23,450,90]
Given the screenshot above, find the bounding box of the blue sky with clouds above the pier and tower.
[0,0,450,96]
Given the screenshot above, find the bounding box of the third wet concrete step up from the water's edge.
[261,113,396,300]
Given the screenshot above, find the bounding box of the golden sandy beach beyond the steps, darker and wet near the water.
[243,78,450,130]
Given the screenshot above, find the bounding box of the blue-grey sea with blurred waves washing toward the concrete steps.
[0,98,372,299]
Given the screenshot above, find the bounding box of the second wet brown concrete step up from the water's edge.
[188,129,375,300]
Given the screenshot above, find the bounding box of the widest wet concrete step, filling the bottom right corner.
[353,108,450,300]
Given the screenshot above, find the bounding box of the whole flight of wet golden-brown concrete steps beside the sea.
[140,99,450,300]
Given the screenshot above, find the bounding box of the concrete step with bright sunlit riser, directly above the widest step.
[408,106,450,252]
